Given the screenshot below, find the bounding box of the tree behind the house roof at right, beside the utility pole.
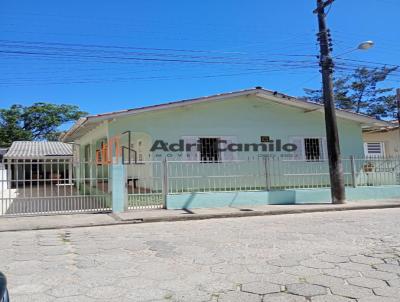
[303,67,397,119]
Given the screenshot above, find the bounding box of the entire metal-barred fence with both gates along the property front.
[0,157,400,215]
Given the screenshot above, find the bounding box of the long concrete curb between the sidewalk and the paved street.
[0,203,400,233]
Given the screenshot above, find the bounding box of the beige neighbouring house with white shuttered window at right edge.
[363,122,400,157]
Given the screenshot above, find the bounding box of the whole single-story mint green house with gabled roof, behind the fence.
[61,87,393,201]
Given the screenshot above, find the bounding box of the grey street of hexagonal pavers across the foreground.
[0,209,400,302]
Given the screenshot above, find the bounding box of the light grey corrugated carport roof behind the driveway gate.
[4,141,72,159]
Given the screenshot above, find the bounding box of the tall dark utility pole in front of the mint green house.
[314,0,346,204]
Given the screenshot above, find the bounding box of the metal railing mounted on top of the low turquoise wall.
[167,157,400,194]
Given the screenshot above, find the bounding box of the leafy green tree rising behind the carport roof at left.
[0,103,87,147]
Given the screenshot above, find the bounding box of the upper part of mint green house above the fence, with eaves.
[63,89,385,162]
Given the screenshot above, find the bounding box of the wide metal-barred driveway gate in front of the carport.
[0,158,111,215]
